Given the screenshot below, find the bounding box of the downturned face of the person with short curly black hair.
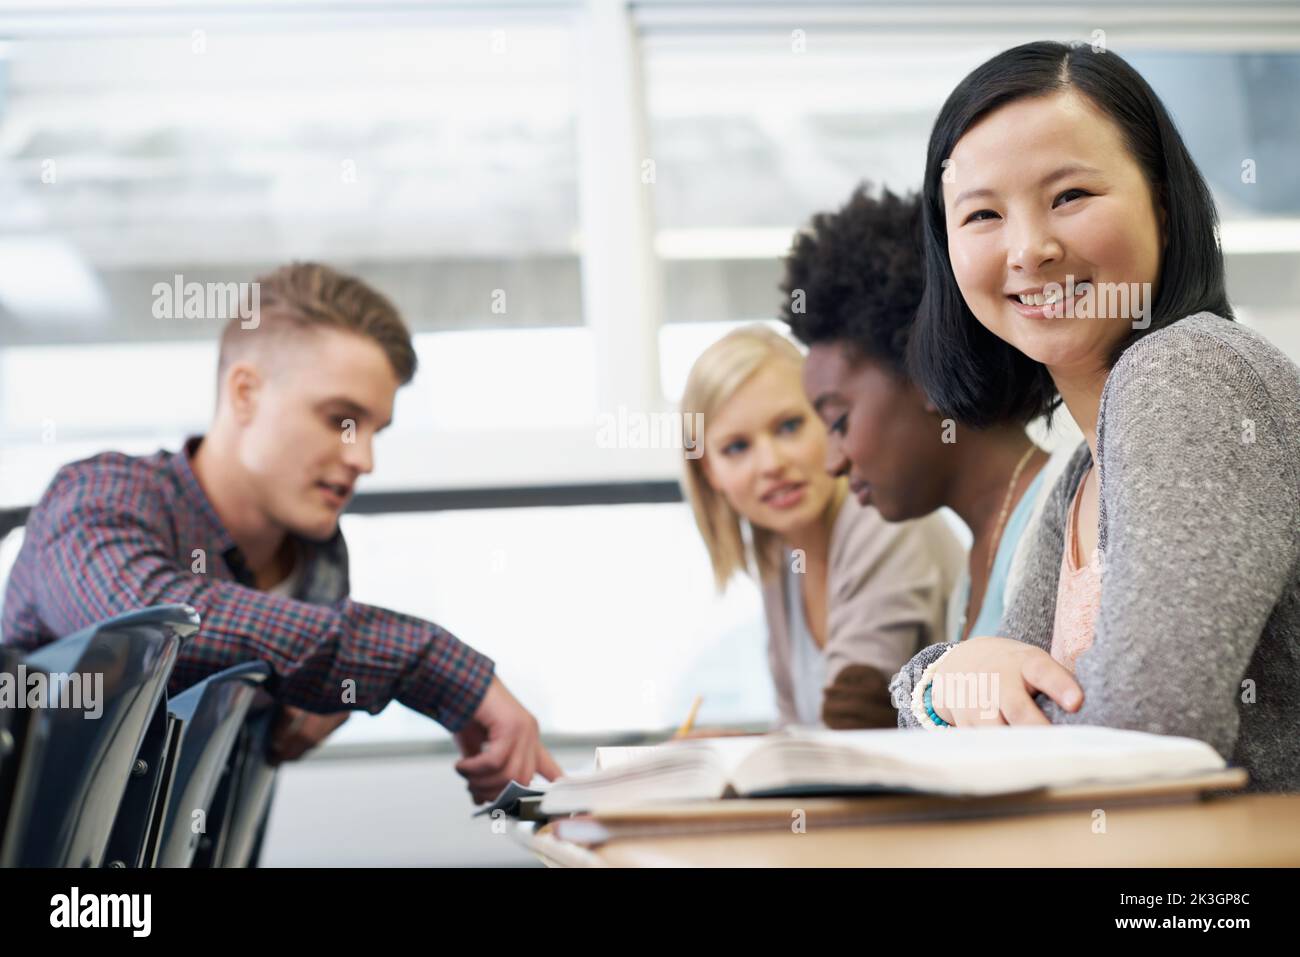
[803,342,950,521]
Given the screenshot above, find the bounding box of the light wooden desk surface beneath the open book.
[520,794,1300,867]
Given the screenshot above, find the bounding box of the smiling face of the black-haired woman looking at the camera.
[944,91,1162,376]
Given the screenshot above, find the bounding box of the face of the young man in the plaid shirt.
[225,329,400,541]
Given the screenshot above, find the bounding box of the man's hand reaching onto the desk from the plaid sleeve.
[456,677,564,804]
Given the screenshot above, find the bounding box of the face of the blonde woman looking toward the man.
[701,359,835,536]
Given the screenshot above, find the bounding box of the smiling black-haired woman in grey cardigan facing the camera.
[893,43,1300,789]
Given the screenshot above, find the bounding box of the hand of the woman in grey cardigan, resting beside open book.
[931,637,1083,728]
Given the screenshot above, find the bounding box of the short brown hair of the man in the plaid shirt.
[217,263,416,385]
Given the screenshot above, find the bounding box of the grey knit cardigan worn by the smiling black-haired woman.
[891,313,1300,791]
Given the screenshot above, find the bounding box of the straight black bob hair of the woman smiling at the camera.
[907,40,1232,428]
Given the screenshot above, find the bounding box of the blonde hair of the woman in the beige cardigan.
[681,325,803,592]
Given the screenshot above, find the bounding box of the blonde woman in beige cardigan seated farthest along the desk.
[681,325,965,728]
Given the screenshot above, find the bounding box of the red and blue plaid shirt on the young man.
[3,438,493,731]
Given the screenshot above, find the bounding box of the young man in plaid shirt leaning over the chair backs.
[3,264,560,801]
